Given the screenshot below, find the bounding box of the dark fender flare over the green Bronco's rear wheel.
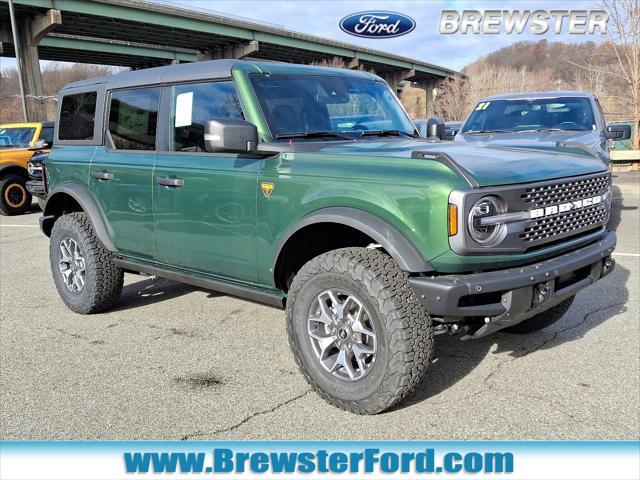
[40,183,118,252]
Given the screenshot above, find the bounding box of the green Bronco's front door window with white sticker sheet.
[169,81,243,152]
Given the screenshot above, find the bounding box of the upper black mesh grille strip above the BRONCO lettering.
[521,173,609,208]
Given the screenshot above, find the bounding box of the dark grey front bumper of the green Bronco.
[409,232,616,338]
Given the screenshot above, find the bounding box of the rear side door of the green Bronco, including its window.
[89,87,160,259]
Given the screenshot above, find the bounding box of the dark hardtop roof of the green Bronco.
[62,59,379,91]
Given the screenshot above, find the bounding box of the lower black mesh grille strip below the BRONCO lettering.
[520,202,609,244]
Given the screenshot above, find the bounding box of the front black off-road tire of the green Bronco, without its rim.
[286,248,433,414]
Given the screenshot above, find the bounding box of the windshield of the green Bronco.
[251,74,414,139]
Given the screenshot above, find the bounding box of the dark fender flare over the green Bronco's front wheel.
[271,207,433,273]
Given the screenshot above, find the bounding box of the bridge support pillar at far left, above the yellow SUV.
[14,9,62,121]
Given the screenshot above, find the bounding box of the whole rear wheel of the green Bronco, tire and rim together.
[49,212,124,314]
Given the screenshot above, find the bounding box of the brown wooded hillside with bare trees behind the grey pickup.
[434,0,640,150]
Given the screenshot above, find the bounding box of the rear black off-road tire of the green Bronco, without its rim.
[49,212,124,314]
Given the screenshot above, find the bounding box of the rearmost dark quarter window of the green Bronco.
[58,92,97,140]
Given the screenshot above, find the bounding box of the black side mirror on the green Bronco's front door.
[204,118,258,153]
